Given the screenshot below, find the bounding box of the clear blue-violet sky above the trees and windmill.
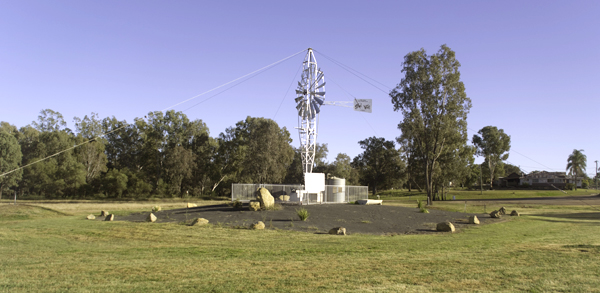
[0,0,600,174]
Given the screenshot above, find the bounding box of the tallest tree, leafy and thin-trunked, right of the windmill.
[390,45,471,204]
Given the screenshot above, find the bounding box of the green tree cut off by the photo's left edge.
[0,130,23,199]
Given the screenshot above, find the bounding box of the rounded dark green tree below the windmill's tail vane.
[352,136,404,194]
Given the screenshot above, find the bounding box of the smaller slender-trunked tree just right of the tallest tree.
[473,126,510,189]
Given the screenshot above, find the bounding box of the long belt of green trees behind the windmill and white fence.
[0,109,516,199]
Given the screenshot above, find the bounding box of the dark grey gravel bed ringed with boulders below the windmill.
[116,204,501,235]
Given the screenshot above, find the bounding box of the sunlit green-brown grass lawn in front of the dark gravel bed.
[0,194,600,292]
